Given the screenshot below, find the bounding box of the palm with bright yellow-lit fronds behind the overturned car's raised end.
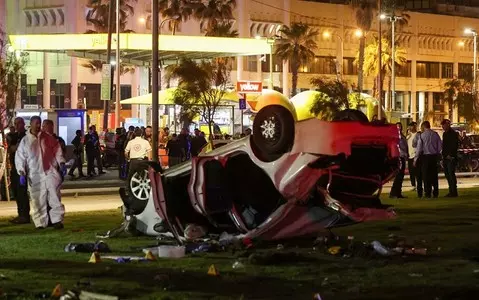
[356,39,407,99]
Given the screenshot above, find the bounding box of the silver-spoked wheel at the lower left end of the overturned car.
[128,162,151,201]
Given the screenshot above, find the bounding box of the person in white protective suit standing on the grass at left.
[15,116,66,229]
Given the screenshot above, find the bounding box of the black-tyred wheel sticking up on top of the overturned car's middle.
[253,105,294,161]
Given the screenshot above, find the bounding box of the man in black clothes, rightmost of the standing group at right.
[441,119,461,197]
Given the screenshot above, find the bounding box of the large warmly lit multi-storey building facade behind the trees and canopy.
[0,0,479,124]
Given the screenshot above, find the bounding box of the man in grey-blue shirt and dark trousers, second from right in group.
[414,121,442,198]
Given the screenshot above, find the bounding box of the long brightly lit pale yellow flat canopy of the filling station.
[10,33,271,66]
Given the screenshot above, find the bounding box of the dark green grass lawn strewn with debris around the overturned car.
[0,189,479,300]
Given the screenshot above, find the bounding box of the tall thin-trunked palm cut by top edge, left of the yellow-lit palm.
[351,0,377,92]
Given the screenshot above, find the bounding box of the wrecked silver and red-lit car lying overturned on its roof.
[122,93,399,241]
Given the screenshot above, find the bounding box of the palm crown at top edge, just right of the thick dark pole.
[159,0,195,35]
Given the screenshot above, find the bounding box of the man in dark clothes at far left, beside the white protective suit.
[7,117,30,224]
